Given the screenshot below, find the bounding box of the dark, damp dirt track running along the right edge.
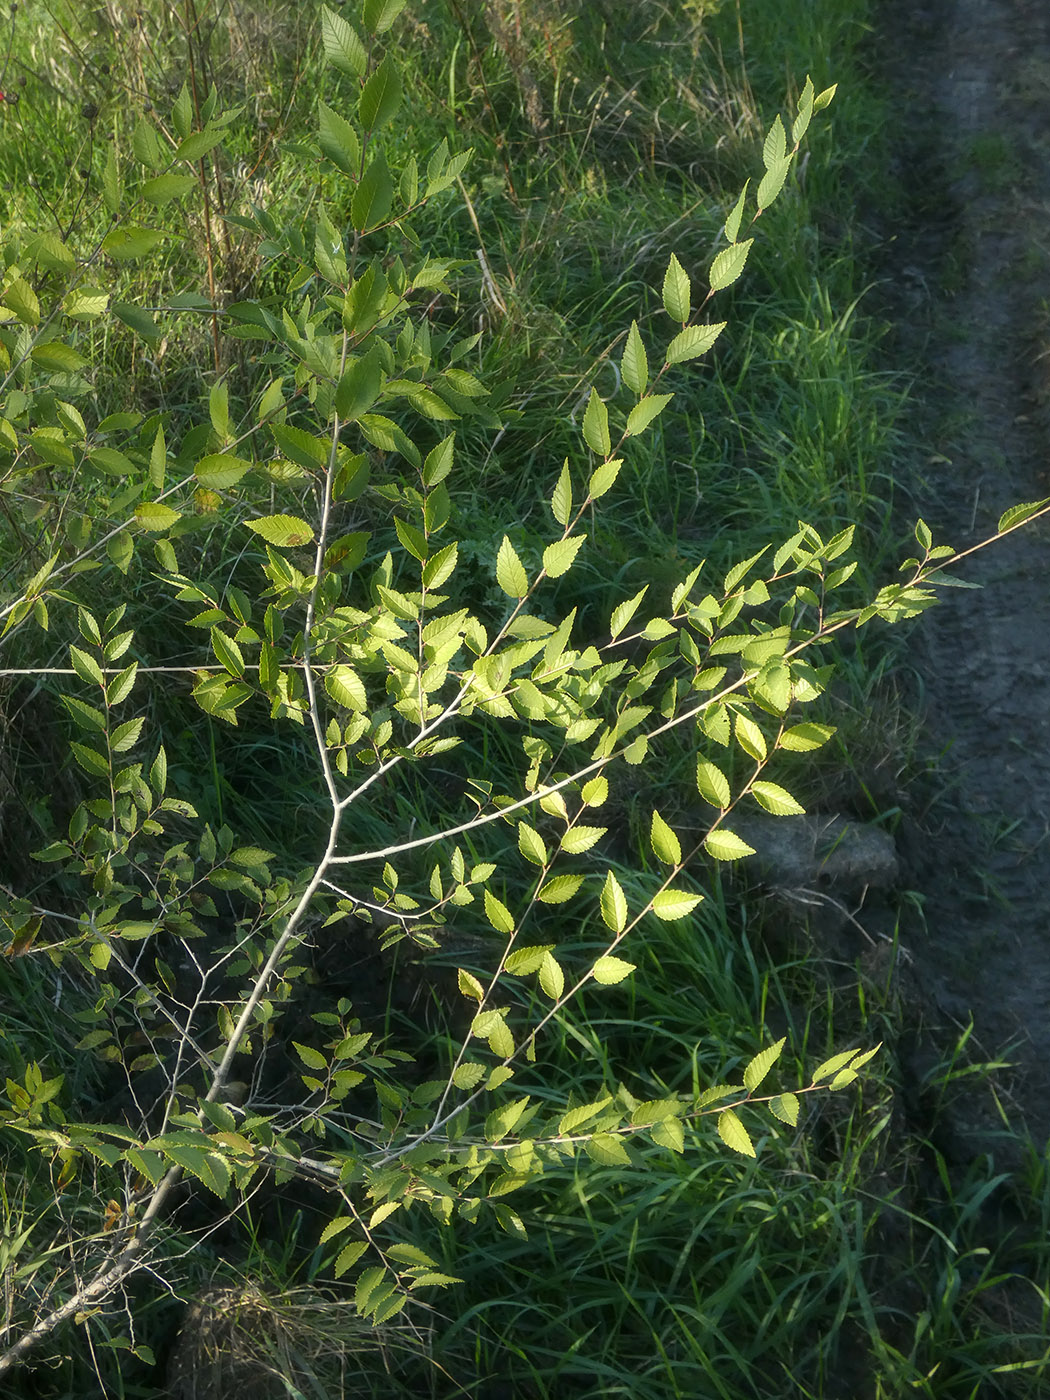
[883,0,1050,1165]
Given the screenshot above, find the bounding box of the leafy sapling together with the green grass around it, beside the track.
[0,0,1037,1396]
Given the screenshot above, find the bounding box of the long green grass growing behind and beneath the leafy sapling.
[0,0,1050,1400]
